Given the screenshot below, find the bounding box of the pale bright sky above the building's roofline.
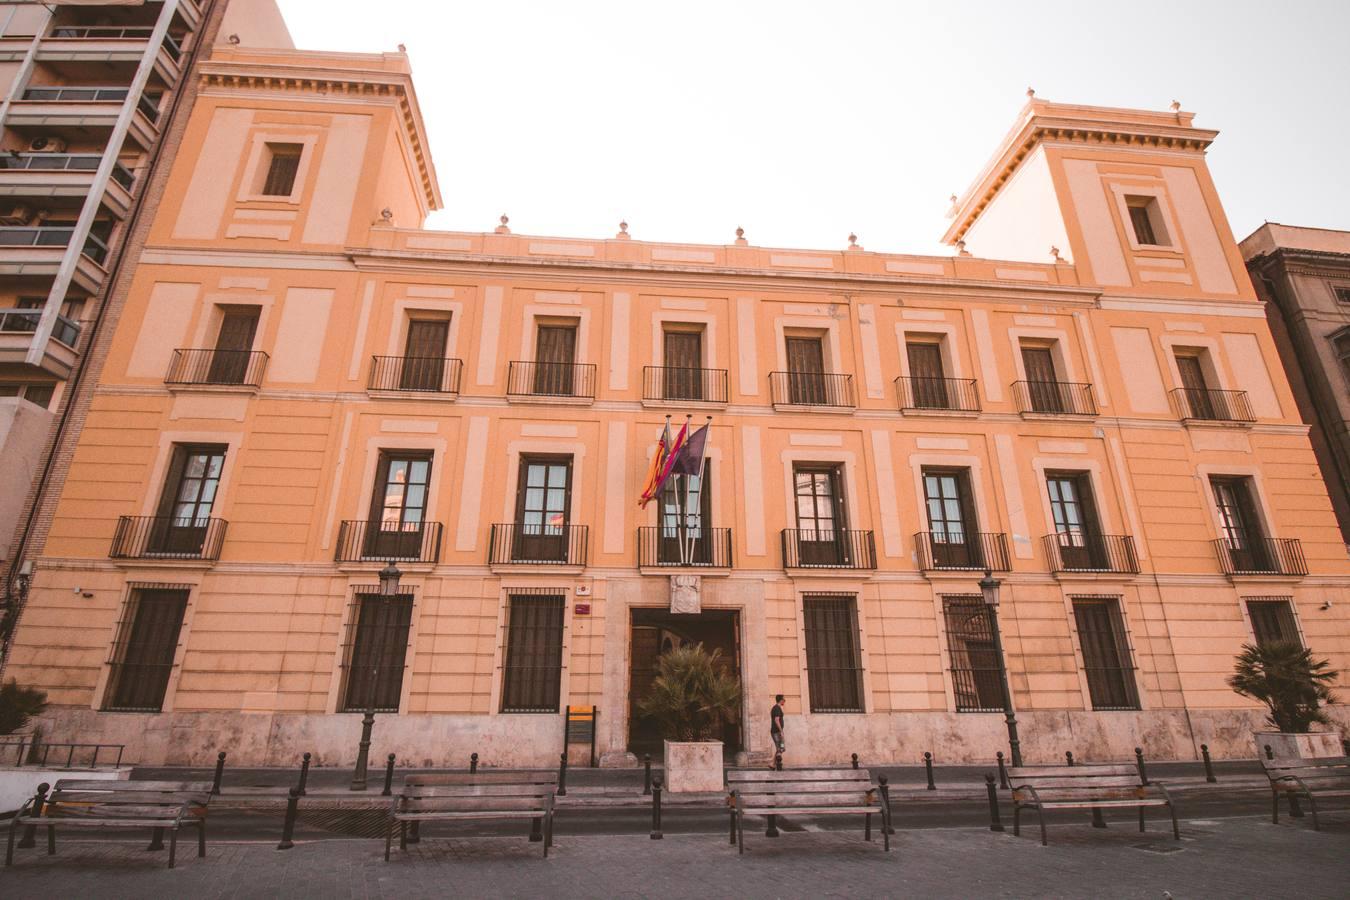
[279,0,1350,254]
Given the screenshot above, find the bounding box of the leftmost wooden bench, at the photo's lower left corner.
[4,779,211,869]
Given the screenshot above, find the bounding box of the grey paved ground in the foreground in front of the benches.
[0,814,1350,900]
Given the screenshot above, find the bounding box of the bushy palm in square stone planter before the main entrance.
[637,644,741,791]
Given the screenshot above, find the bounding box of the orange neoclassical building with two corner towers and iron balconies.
[5,36,1350,765]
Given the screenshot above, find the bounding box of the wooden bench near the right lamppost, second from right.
[1008,764,1181,846]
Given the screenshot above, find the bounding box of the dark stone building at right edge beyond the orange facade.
[1242,223,1350,545]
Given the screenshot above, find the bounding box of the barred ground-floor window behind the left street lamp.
[340,587,413,712]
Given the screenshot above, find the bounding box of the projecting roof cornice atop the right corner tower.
[942,99,1219,244]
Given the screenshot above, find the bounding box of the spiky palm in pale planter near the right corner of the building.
[1229,641,1339,756]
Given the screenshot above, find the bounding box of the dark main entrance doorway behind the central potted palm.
[628,607,745,760]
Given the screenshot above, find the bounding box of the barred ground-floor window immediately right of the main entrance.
[802,594,863,712]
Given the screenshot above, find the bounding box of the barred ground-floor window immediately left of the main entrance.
[502,590,567,712]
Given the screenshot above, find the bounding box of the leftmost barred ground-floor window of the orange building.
[103,584,190,712]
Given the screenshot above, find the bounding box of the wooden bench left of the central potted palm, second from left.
[385,772,558,862]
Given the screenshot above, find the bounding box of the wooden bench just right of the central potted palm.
[726,769,891,853]
